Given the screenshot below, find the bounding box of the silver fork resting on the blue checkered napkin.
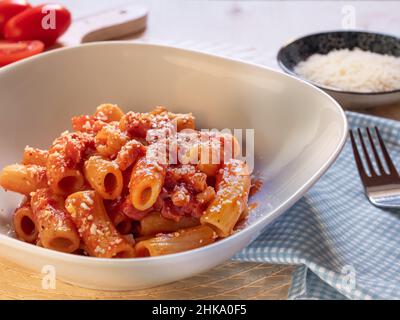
[350,127,400,208]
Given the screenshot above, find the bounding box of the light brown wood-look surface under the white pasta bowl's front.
[0,259,292,300]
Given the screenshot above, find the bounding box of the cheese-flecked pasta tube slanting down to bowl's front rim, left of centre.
[65,190,135,258]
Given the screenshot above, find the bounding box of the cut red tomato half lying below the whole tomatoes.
[0,40,44,67]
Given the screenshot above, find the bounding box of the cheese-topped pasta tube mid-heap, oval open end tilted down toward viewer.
[129,149,166,211]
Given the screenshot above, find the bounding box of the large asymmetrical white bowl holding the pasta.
[0,42,347,290]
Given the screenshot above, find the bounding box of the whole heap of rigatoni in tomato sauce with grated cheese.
[0,104,251,258]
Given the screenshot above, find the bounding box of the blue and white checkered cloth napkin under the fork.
[235,112,400,299]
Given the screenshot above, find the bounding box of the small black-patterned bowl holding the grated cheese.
[277,31,400,108]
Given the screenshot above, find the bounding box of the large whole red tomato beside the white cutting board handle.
[4,4,71,46]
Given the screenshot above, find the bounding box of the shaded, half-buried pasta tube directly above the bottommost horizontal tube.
[138,212,200,236]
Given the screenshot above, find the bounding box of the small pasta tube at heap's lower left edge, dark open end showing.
[13,203,38,243]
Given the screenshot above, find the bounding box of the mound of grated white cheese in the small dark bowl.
[295,48,400,92]
